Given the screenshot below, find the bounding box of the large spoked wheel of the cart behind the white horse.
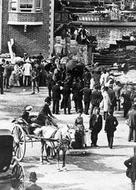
[12,125,26,161]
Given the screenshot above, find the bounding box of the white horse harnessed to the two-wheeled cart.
[34,124,75,171]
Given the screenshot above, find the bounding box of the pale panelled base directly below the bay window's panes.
[8,12,43,25]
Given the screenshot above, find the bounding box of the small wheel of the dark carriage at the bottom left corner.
[12,163,25,182]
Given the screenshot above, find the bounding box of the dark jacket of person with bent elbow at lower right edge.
[124,156,136,182]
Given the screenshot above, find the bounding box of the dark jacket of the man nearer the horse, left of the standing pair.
[89,114,102,133]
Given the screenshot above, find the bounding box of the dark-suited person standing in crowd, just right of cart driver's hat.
[52,82,61,114]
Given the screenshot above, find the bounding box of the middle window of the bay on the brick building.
[20,0,33,12]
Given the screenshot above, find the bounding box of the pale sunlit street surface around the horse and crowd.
[0,88,135,190]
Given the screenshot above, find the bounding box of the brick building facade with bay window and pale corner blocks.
[0,0,54,57]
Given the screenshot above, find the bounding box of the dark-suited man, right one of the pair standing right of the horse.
[105,110,118,148]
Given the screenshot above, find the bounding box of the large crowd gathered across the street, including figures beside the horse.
[0,47,136,148]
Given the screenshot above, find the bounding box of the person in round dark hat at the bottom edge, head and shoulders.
[26,172,42,190]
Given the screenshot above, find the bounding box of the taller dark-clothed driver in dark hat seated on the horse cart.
[36,96,57,126]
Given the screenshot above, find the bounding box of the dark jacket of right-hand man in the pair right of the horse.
[105,115,118,135]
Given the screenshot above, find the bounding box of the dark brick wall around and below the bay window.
[2,0,50,57]
